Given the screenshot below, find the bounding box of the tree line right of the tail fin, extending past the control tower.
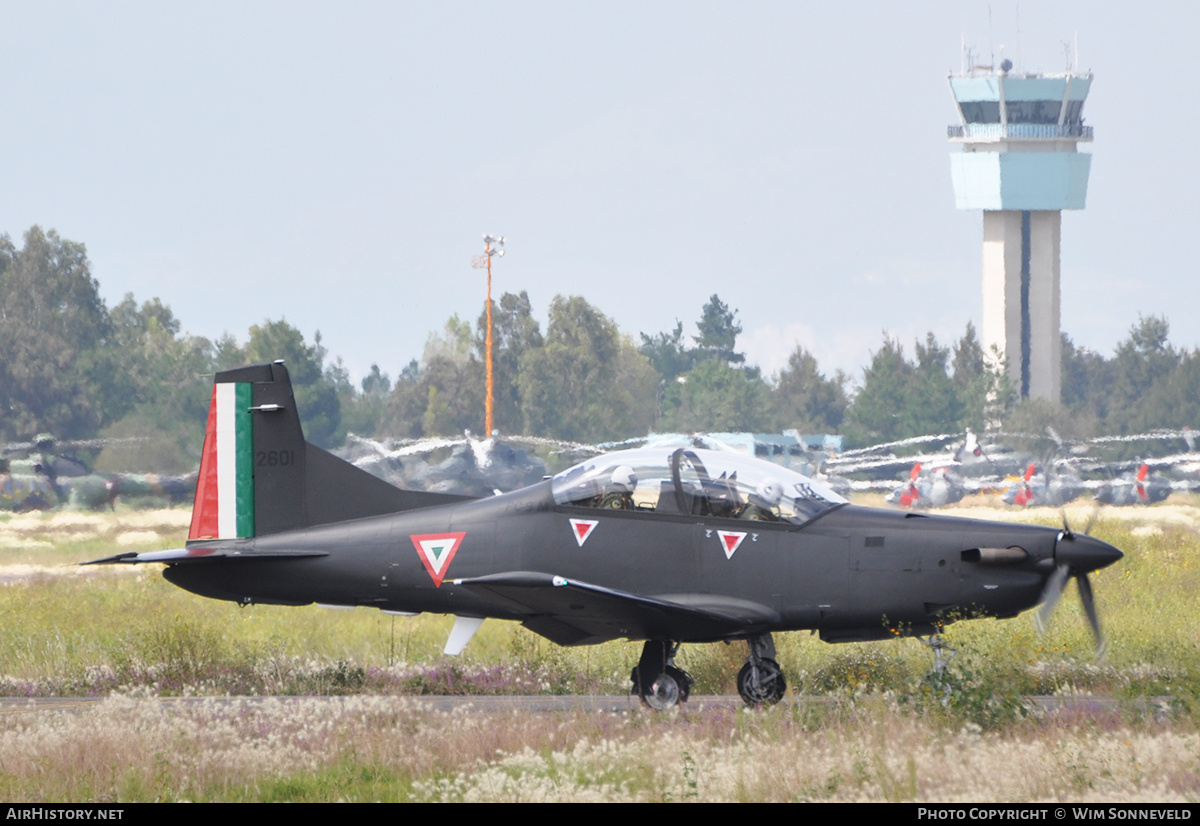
[338,293,1200,445]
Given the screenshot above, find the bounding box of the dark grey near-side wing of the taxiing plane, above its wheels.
[454,571,780,645]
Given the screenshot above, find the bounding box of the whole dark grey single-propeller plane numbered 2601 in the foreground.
[88,361,1122,708]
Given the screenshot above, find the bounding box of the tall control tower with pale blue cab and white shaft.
[948,60,1092,402]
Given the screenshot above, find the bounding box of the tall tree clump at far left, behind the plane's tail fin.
[0,227,355,472]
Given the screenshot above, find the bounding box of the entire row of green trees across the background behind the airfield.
[0,227,1200,472]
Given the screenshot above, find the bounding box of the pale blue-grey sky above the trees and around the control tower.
[0,0,1200,386]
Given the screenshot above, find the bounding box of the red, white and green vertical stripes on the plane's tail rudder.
[187,382,254,539]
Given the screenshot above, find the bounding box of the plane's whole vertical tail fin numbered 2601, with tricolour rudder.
[187,361,469,540]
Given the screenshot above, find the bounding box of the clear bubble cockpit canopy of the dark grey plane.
[551,448,846,525]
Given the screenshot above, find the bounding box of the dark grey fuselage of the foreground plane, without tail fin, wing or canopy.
[166,483,1116,642]
